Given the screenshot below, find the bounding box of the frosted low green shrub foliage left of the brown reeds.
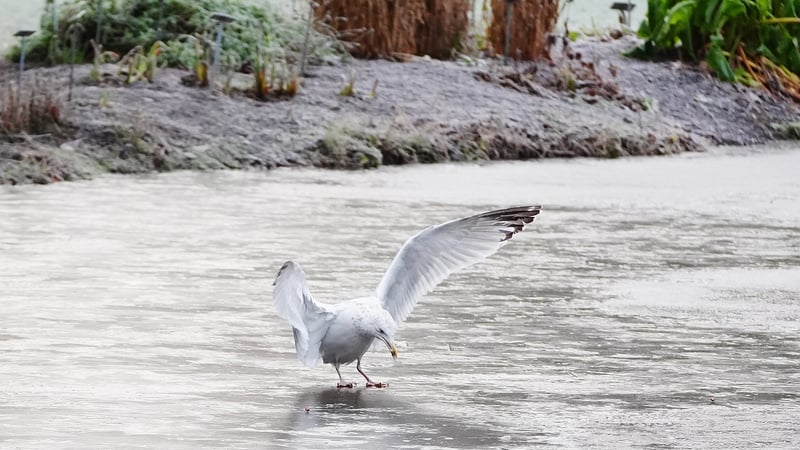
[8,0,344,68]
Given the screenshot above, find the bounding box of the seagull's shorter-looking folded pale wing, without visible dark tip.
[273,261,335,367]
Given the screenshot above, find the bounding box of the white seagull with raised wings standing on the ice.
[273,205,542,388]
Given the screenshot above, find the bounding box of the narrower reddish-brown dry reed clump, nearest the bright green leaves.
[488,0,558,60]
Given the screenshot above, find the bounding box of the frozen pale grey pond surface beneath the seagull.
[0,147,800,449]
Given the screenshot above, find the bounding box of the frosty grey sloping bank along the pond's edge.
[0,37,798,184]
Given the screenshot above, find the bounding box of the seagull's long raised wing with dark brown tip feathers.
[377,206,542,324]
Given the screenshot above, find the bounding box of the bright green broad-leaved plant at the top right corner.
[632,0,800,82]
